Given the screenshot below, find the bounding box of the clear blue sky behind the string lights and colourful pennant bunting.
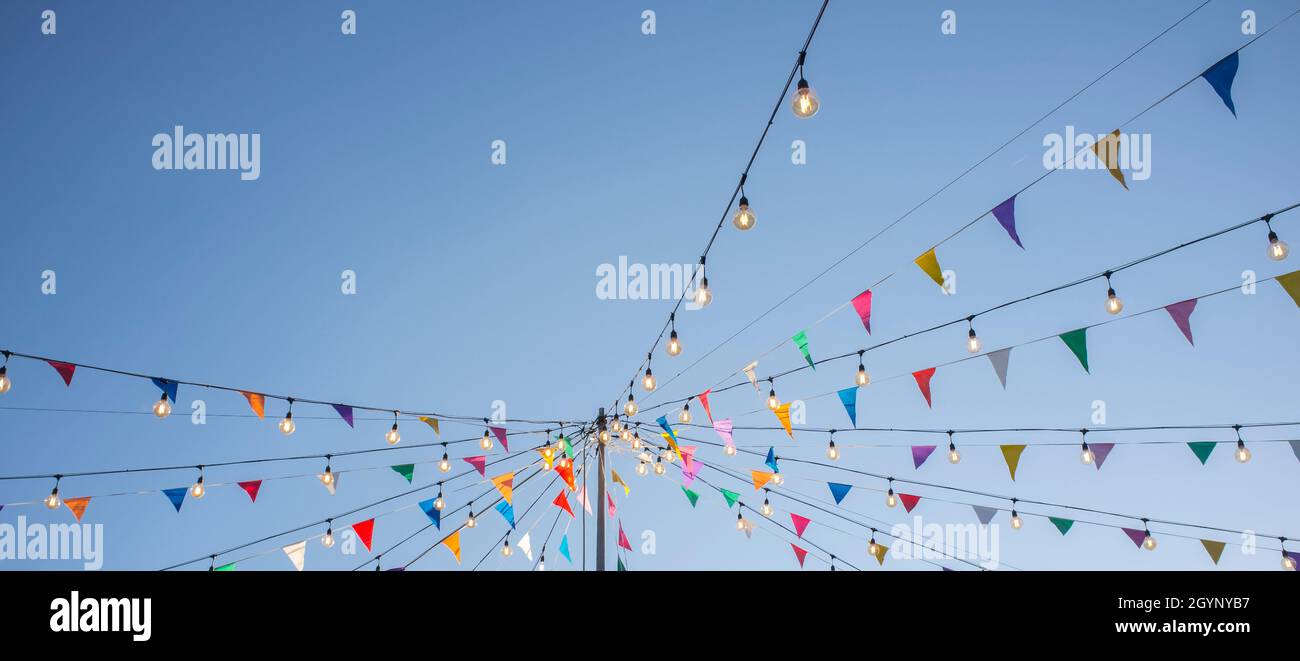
[0,0,1300,570]
